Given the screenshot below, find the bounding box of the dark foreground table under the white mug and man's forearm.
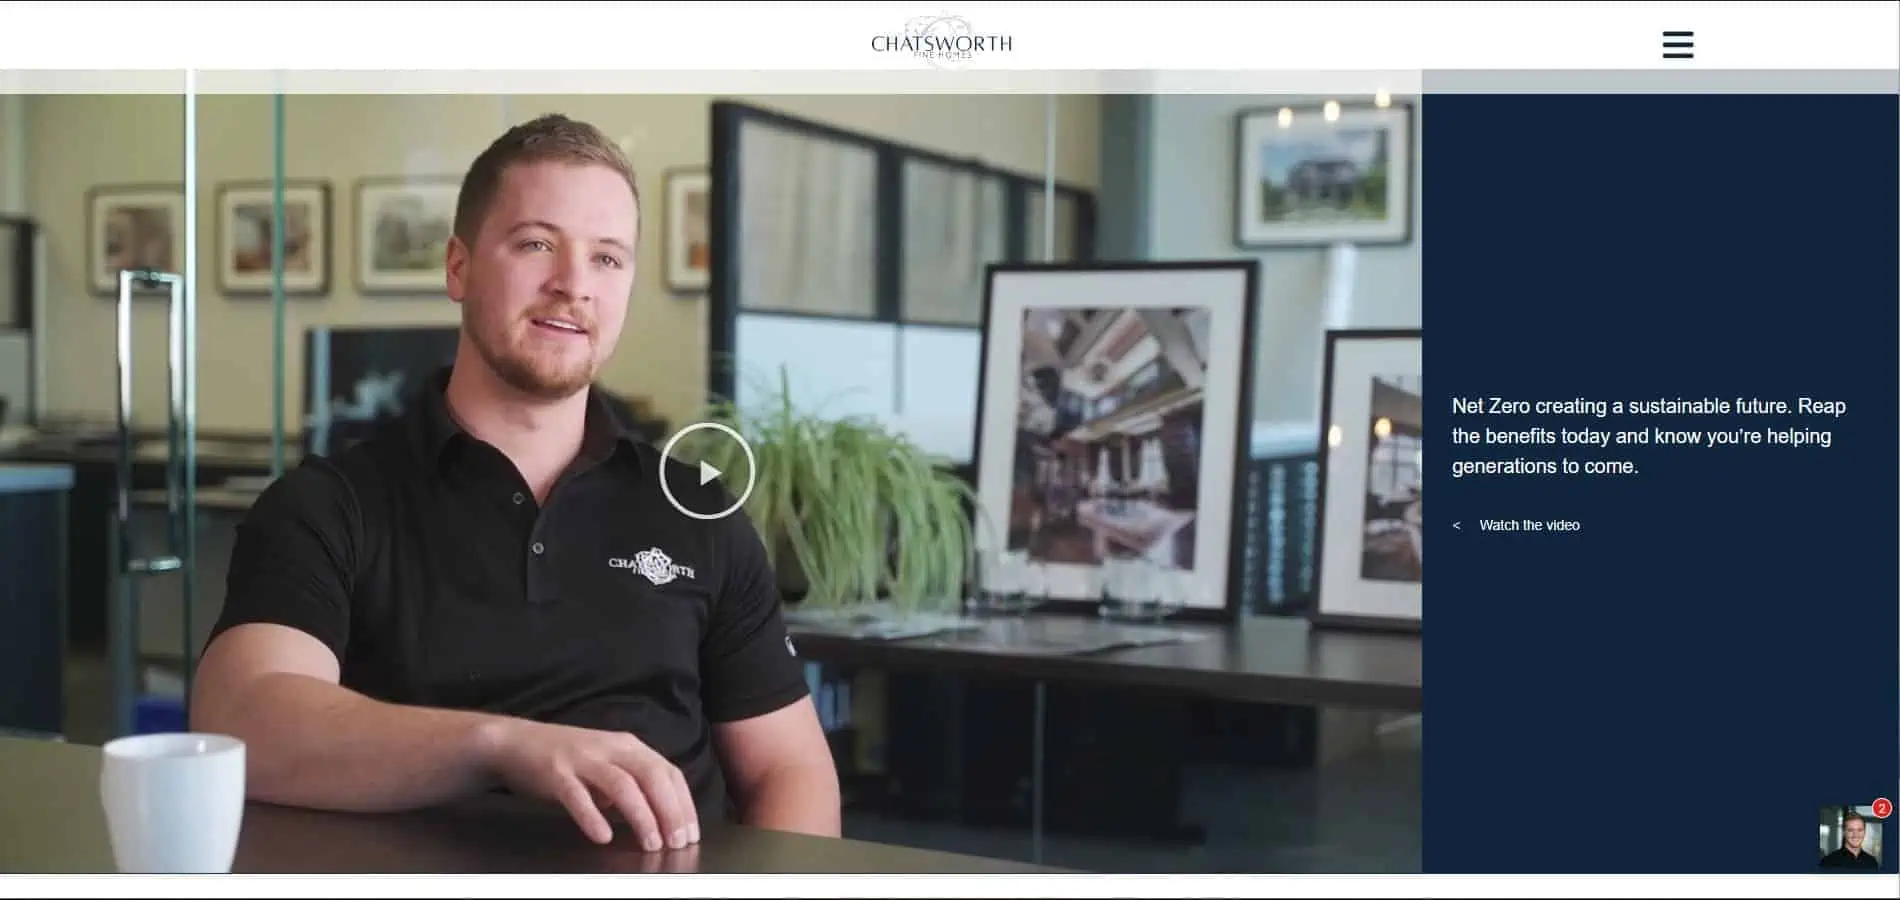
[0,739,1058,875]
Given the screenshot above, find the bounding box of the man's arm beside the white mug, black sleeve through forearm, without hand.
[192,463,513,811]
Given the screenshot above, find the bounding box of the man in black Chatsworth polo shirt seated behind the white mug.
[192,116,840,851]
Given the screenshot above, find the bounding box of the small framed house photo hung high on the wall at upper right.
[1233,103,1414,249]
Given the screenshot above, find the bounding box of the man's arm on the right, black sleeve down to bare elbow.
[699,513,842,837]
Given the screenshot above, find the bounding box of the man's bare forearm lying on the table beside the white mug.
[192,674,502,813]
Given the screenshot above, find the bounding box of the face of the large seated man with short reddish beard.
[448,161,640,399]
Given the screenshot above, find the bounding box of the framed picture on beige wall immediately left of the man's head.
[355,177,462,294]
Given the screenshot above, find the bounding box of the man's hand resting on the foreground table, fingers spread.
[490,720,699,853]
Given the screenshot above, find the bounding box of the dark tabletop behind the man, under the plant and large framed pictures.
[779,617,1425,712]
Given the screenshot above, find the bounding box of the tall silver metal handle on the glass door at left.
[114,270,194,575]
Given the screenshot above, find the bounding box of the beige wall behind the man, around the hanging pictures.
[22,95,1100,431]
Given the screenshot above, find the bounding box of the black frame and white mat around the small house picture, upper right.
[1233,101,1417,251]
